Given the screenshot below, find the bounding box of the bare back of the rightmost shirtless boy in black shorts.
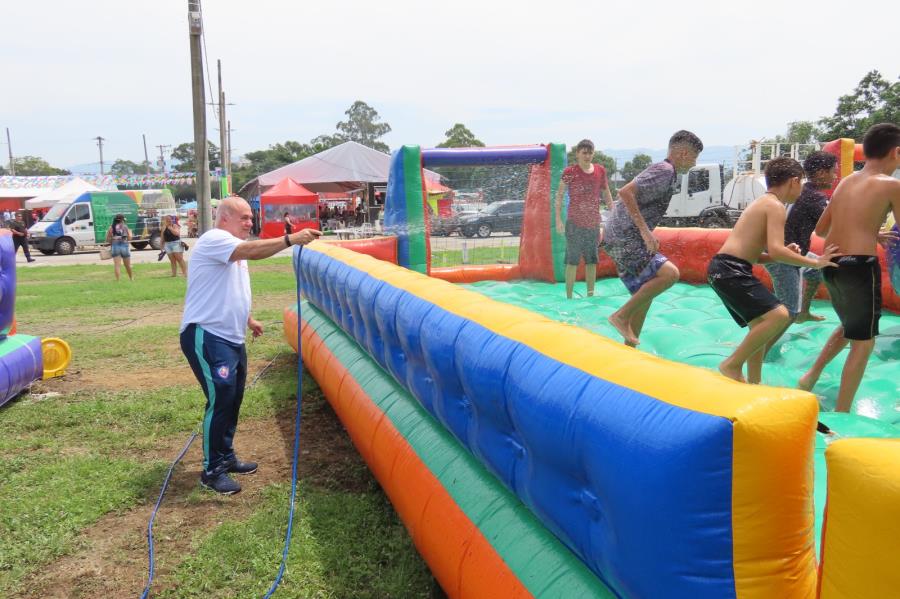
[820,169,900,256]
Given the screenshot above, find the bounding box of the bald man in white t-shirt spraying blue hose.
[181,196,321,495]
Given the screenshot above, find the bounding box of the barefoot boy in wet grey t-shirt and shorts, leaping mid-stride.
[603,131,703,347]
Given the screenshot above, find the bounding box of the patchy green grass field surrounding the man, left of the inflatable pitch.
[0,258,433,598]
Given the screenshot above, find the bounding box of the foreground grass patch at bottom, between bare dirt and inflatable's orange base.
[160,485,430,598]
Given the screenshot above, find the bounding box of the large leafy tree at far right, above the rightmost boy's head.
[819,70,900,140]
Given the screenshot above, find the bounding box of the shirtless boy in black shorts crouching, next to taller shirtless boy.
[707,158,837,383]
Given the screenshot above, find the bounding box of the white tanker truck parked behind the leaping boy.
[661,142,819,228]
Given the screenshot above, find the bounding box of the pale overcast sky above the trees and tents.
[0,0,900,167]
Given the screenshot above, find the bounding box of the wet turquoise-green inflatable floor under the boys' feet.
[465,279,900,556]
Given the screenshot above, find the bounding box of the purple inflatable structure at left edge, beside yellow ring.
[0,231,44,406]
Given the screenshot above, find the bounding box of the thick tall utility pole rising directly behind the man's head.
[188,0,213,235]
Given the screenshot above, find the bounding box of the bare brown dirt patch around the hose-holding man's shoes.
[21,386,376,599]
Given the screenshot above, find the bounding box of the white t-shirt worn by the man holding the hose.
[181,229,251,343]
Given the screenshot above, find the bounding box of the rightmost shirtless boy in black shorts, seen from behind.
[799,123,900,412]
